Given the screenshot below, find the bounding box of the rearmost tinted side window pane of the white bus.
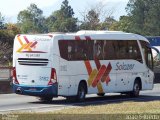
[59,40,94,60]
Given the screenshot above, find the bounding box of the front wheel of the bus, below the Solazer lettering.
[131,80,140,97]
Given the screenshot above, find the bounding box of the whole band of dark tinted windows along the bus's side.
[59,40,142,62]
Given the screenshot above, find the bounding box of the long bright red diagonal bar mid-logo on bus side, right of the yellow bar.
[92,65,107,87]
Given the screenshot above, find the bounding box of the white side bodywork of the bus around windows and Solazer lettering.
[59,34,154,96]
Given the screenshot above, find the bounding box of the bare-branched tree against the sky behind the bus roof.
[80,2,116,30]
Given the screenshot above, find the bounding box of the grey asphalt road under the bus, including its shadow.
[0,84,160,114]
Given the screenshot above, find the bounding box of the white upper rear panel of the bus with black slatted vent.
[13,35,53,86]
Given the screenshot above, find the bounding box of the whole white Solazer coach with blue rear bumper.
[13,31,154,101]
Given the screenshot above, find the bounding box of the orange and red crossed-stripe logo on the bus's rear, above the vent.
[17,35,45,53]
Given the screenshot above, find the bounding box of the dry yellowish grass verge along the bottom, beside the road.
[9,100,160,120]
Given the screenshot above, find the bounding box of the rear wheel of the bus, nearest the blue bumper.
[77,82,86,102]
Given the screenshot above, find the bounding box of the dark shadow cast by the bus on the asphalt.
[30,95,160,106]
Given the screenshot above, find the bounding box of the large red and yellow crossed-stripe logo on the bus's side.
[85,58,112,93]
